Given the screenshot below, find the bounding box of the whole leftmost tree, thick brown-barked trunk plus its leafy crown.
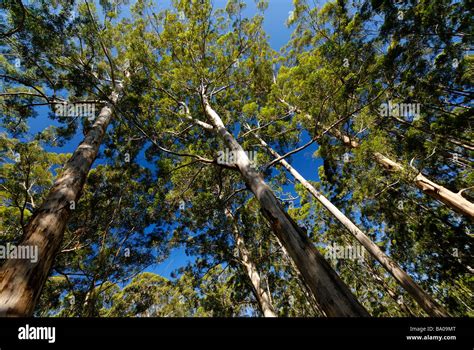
[0,2,139,316]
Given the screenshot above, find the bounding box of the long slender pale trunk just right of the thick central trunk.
[254,134,449,317]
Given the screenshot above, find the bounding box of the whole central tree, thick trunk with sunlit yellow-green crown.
[135,1,367,316]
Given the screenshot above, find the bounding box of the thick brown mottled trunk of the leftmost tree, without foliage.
[0,80,123,317]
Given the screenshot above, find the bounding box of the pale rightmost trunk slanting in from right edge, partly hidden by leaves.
[330,129,474,220]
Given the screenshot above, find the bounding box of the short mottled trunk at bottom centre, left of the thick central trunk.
[225,208,277,317]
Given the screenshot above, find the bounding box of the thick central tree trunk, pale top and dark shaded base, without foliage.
[202,93,369,317]
